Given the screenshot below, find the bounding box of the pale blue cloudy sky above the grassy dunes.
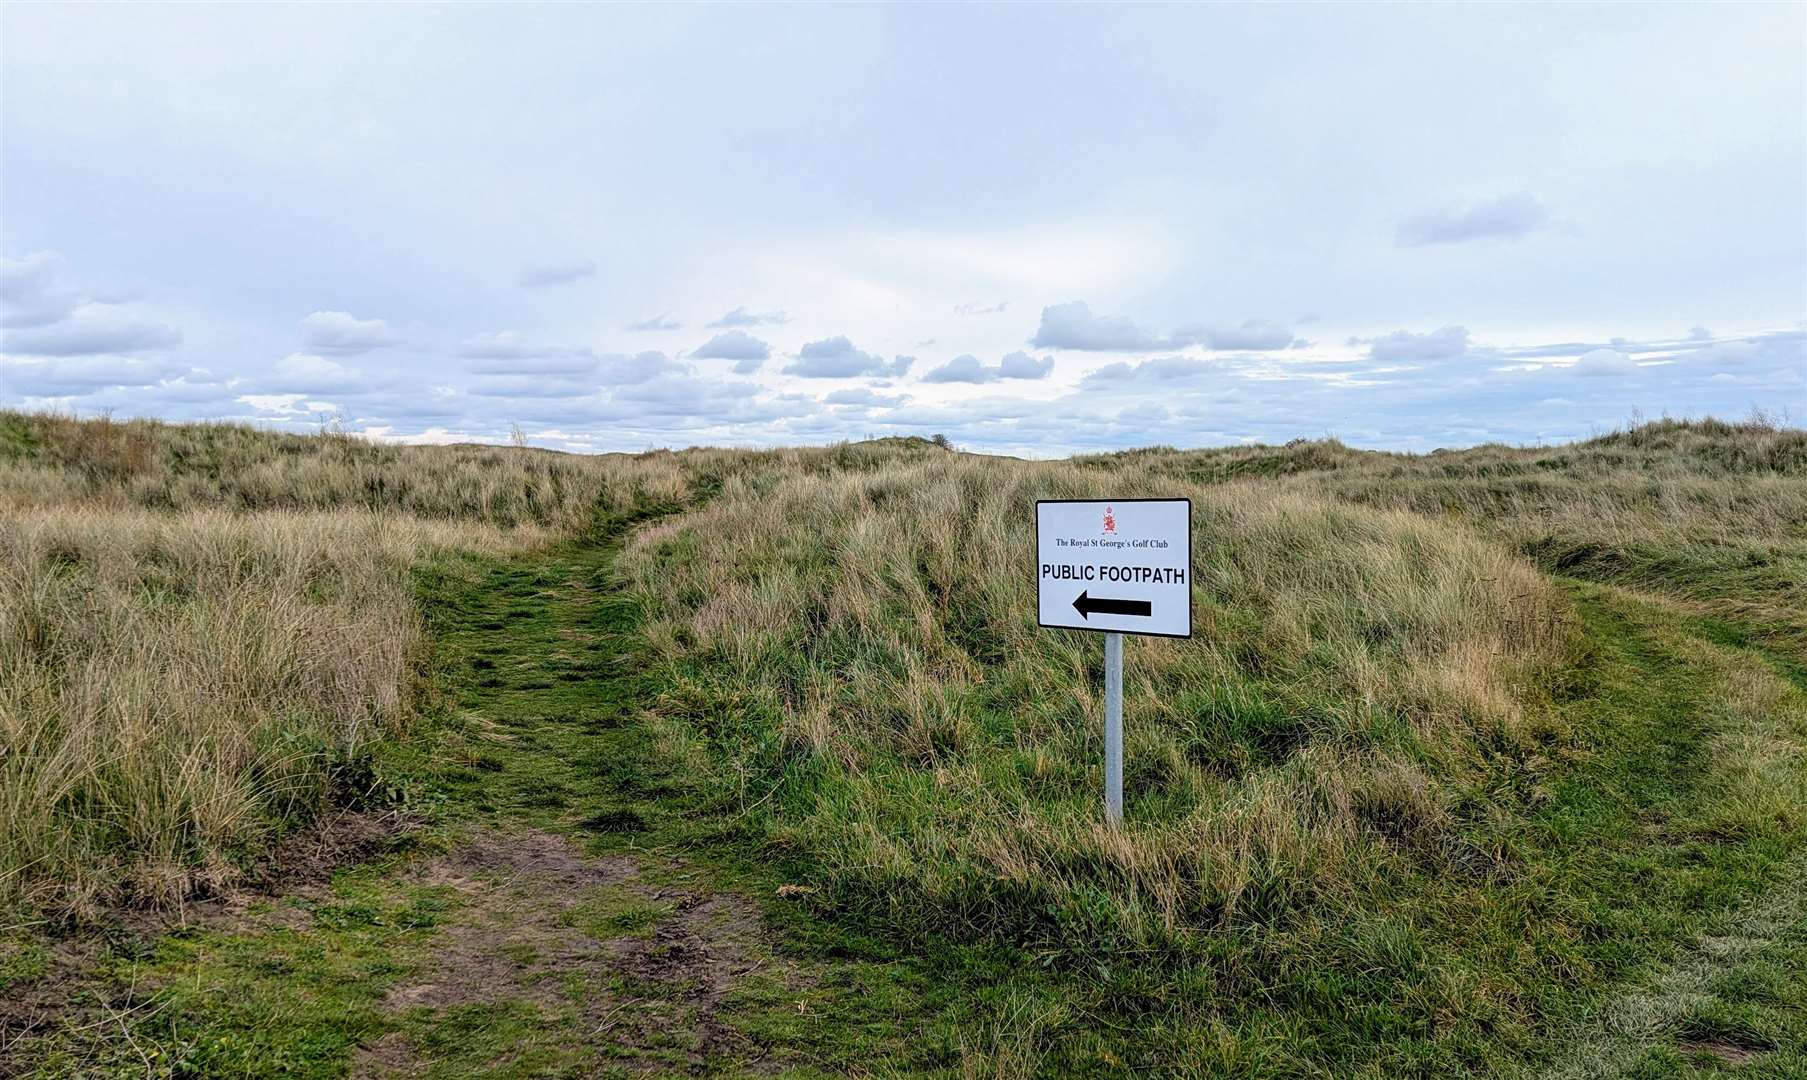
[0,4,1807,457]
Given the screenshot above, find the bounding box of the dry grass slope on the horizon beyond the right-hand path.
[1082,415,1807,642]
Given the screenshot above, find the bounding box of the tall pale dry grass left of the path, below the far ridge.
[0,507,519,914]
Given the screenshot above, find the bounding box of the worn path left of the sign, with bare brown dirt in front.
[339,523,810,1076]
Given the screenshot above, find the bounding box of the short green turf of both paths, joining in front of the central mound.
[0,487,1807,1078]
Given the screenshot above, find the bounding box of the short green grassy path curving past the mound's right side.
[1509,580,1807,1080]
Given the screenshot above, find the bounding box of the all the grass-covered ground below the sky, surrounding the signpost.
[0,414,1807,1076]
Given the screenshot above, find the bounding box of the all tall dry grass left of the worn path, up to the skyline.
[0,412,688,916]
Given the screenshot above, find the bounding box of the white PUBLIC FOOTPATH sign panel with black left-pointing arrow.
[1035,498,1193,638]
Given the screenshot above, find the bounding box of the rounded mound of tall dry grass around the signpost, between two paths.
[623,455,1567,943]
